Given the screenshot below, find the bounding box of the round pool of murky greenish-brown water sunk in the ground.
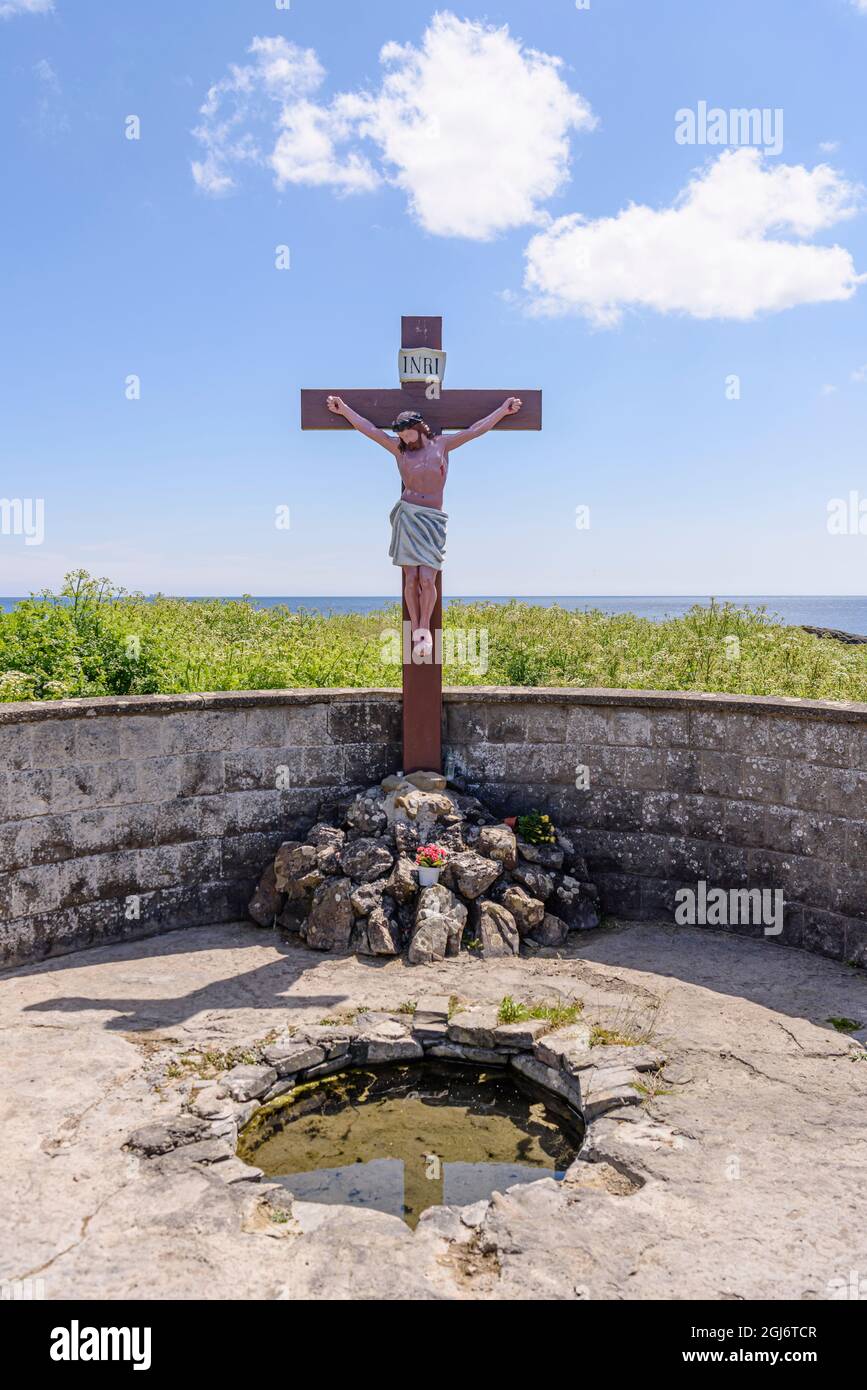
[239,1063,581,1227]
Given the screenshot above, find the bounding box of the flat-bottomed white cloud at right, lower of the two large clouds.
[524,149,867,327]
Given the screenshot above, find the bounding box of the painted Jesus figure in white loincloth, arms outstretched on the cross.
[322,396,522,651]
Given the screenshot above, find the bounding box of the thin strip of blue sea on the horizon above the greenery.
[0,594,867,635]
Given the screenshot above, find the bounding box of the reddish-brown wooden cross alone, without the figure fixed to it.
[302,309,542,773]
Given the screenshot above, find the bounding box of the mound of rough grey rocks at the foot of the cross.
[250,773,599,963]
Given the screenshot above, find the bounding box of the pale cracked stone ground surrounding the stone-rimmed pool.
[0,924,867,1300]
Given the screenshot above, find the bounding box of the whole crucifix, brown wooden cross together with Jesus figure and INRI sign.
[302,317,542,774]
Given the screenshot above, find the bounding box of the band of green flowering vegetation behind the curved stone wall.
[0,570,867,701]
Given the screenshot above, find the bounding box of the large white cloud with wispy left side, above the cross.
[193,14,596,240]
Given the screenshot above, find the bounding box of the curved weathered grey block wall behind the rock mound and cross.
[0,687,867,966]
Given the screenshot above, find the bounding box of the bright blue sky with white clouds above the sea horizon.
[0,0,867,595]
